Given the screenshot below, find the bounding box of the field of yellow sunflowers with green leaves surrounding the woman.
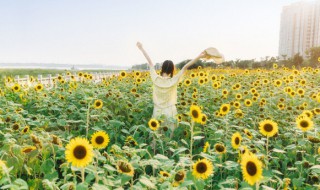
[0,64,320,190]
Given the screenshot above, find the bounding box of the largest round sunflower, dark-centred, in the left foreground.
[65,137,93,167]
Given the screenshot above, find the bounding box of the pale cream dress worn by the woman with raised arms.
[150,67,183,118]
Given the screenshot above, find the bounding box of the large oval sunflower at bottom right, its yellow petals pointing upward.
[241,154,262,185]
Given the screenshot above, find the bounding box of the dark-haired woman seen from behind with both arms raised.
[137,42,207,121]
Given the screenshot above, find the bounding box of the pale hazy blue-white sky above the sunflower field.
[0,0,297,66]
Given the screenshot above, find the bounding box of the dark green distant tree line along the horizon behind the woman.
[131,47,320,70]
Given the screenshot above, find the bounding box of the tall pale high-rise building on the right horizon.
[279,0,320,59]
